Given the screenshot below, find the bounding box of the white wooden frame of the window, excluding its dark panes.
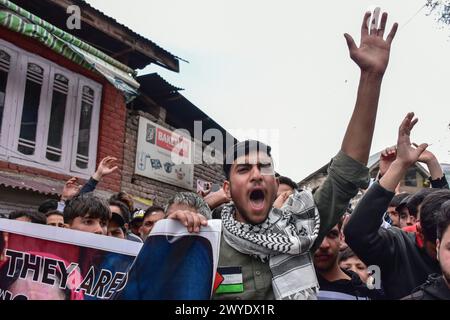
[0,39,103,178]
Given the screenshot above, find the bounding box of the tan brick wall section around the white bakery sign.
[122,110,225,205]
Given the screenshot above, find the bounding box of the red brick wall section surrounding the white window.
[0,27,126,192]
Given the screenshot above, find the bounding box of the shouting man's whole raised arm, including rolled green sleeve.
[313,13,397,249]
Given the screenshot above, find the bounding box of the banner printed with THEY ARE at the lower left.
[0,219,141,300]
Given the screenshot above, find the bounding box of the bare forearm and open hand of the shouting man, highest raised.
[341,12,398,165]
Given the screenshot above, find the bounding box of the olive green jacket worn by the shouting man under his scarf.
[213,151,369,300]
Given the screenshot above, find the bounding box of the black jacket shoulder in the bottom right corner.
[402,274,450,300]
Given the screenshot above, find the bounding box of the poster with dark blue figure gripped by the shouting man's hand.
[119,219,222,300]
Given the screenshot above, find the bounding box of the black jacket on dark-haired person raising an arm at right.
[344,182,440,299]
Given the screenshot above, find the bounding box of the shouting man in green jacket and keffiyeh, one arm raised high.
[168,12,397,300]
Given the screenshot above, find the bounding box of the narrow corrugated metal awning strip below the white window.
[0,172,64,196]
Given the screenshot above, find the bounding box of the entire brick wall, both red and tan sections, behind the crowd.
[0,27,224,205]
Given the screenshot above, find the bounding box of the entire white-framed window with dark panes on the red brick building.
[0,40,102,176]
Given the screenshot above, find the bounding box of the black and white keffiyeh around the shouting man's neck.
[222,191,320,300]
